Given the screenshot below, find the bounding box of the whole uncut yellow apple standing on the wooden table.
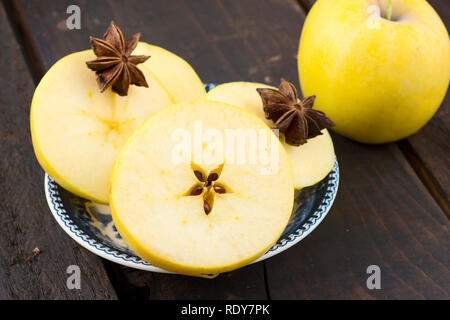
[298,0,450,143]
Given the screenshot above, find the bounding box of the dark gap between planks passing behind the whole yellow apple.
[296,0,450,219]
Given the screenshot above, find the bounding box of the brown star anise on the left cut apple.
[86,21,150,96]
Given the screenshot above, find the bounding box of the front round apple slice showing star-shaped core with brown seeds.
[110,100,294,275]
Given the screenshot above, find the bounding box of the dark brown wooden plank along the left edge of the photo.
[0,3,116,299]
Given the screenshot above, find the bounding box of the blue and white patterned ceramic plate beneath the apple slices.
[45,85,339,273]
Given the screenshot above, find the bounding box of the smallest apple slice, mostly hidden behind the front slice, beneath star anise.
[206,82,335,189]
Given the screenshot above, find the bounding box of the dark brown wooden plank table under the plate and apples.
[0,0,450,299]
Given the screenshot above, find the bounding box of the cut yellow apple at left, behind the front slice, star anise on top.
[30,43,205,203]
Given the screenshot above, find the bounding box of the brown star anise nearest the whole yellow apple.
[256,79,334,146]
